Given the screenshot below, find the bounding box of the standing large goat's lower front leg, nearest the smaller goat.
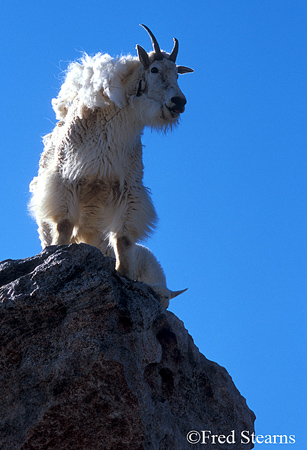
[113,236,135,280]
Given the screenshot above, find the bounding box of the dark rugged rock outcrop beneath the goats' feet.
[0,244,255,450]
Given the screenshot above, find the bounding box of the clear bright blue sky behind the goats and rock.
[0,0,307,444]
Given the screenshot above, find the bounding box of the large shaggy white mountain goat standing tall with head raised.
[29,25,193,300]
